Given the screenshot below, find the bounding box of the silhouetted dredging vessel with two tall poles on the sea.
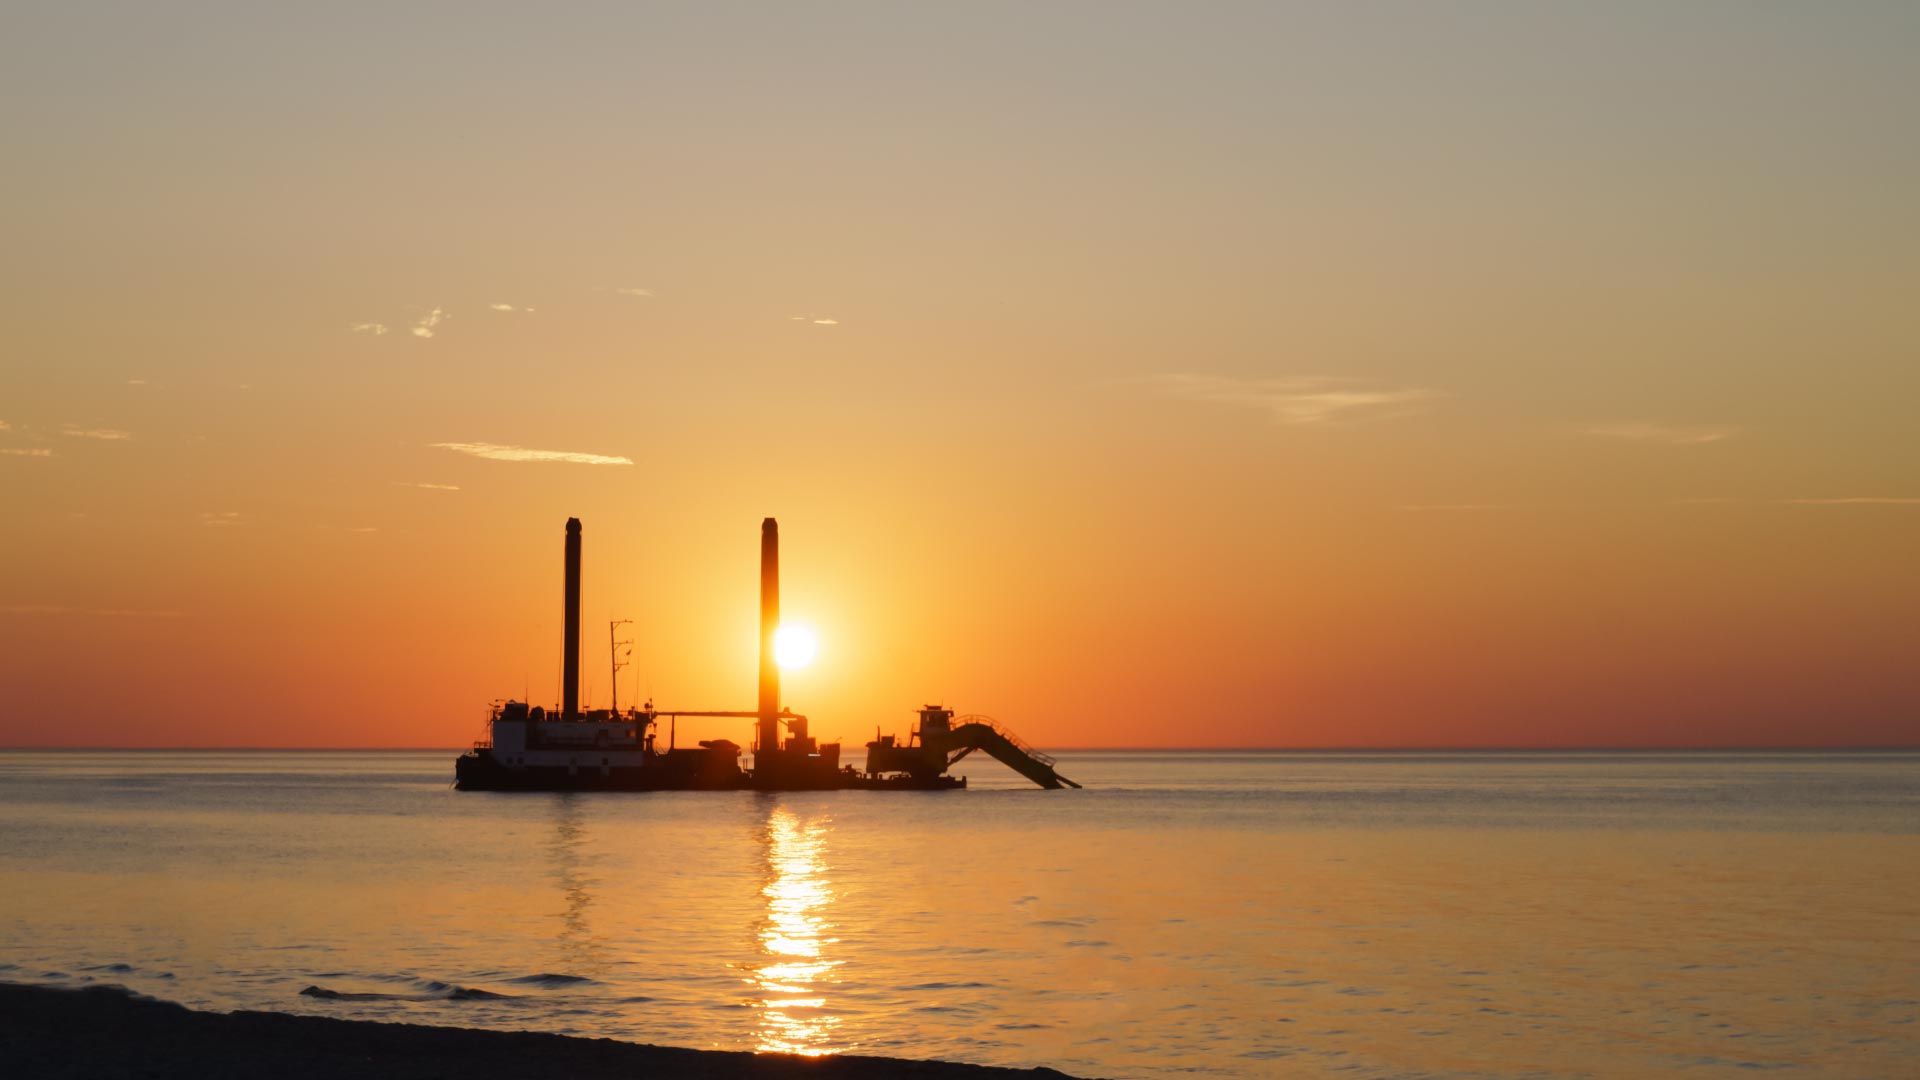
[453,517,1079,792]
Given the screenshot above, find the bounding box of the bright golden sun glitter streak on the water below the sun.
[749,807,841,1057]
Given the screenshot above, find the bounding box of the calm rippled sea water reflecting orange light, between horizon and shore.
[0,751,1920,1078]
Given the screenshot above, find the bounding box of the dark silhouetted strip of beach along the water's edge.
[0,984,1066,1080]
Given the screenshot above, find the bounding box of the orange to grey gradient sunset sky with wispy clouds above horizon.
[0,2,1920,748]
